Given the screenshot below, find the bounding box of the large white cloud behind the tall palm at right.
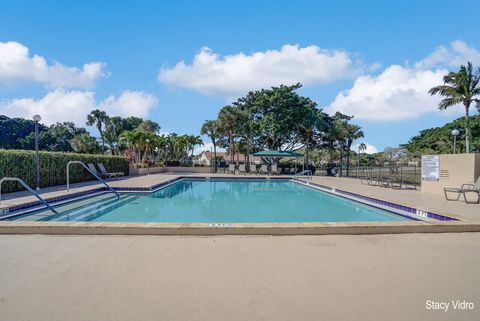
[326,41,479,121]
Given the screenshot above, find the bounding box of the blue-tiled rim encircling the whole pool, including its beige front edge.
[0,176,480,236]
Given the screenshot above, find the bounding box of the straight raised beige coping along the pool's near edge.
[0,221,480,236]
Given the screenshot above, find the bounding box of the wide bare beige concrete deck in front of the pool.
[0,233,480,321]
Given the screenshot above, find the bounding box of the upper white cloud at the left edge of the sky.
[0,41,107,88]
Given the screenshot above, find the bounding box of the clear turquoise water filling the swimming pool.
[8,180,407,223]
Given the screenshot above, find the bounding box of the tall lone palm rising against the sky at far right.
[428,62,480,154]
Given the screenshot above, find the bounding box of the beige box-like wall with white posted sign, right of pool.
[421,153,480,195]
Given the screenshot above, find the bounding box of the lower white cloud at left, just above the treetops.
[0,89,157,126]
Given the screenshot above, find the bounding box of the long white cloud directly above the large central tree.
[158,45,364,95]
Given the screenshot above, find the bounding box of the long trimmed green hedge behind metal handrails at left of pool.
[0,149,128,193]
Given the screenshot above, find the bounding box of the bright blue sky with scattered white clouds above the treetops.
[0,0,480,150]
